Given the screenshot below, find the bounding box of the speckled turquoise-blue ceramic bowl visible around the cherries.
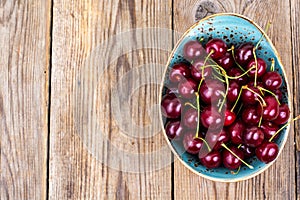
[161,13,291,182]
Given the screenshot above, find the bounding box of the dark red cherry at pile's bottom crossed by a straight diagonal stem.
[222,146,244,170]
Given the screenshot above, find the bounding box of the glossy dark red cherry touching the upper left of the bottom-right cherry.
[243,126,265,147]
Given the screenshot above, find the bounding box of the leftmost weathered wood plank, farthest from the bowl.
[0,0,50,200]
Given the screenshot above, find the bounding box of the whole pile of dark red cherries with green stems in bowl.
[161,38,290,170]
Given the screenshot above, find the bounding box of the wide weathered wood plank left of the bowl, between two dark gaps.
[49,0,172,199]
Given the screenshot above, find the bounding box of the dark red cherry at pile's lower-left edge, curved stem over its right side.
[183,132,203,154]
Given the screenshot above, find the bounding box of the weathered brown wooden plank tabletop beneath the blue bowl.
[0,0,300,200]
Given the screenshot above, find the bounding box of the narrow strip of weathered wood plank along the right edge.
[291,0,300,199]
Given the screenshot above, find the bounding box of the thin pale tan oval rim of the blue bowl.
[159,12,293,183]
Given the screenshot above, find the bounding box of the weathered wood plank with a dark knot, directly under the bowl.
[174,0,299,199]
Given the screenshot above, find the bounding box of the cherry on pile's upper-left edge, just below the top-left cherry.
[169,63,191,83]
